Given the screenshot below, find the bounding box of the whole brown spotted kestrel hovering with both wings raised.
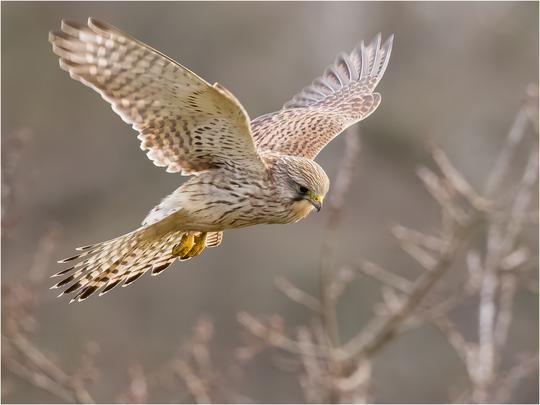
[49,18,393,301]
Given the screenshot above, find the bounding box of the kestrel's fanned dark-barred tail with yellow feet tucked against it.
[51,225,222,302]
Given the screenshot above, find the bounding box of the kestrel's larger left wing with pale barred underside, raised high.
[49,18,263,174]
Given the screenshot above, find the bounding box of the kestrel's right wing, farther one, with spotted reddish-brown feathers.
[251,34,394,159]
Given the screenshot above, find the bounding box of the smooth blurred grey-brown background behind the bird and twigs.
[1,2,539,403]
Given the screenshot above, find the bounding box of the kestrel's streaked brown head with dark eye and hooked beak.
[274,156,330,215]
